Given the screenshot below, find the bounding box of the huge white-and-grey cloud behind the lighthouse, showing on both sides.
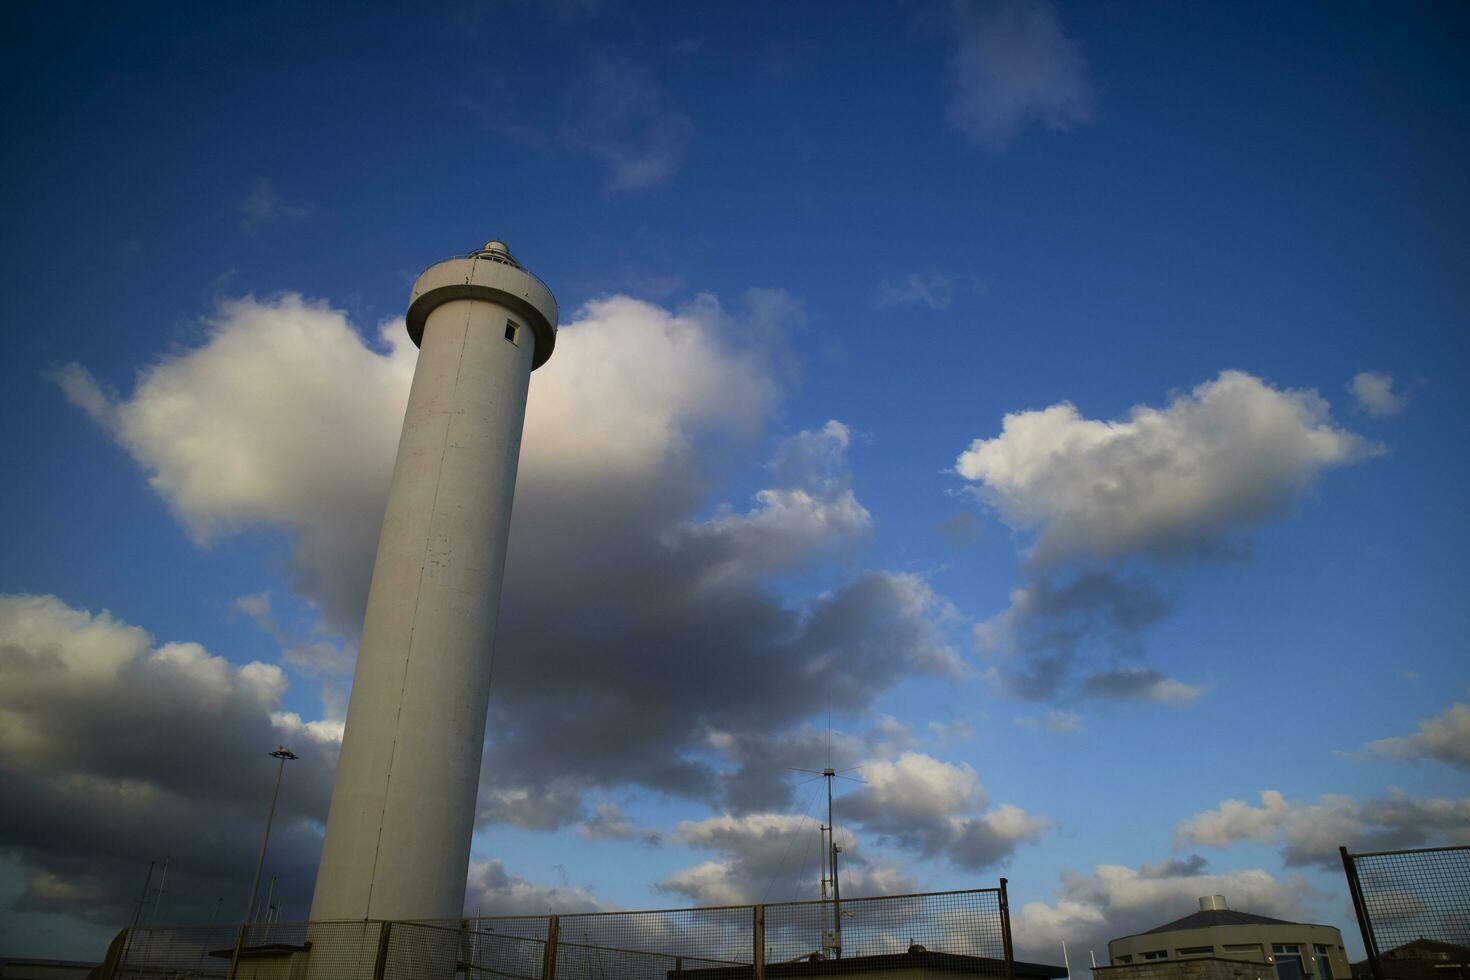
[59,289,967,910]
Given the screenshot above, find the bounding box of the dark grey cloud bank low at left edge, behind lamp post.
[0,597,337,926]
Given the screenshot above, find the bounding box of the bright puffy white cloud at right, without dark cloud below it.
[956,370,1379,566]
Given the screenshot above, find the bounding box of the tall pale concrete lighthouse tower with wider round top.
[312,241,557,921]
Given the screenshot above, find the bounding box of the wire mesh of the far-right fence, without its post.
[1347,846,1470,958]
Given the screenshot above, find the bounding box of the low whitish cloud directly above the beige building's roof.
[1014,858,1311,961]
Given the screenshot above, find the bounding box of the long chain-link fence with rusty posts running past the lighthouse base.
[97,880,1014,980]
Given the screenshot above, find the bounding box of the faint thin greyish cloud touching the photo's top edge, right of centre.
[945,0,1095,148]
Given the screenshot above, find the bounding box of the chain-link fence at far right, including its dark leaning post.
[1341,846,1470,980]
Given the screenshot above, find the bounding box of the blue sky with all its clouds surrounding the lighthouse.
[0,0,1470,958]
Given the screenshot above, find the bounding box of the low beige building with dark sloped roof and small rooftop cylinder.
[1094,895,1352,980]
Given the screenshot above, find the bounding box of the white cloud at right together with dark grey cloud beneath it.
[956,370,1380,704]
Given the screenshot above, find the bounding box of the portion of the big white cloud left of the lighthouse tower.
[62,294,417,633]
